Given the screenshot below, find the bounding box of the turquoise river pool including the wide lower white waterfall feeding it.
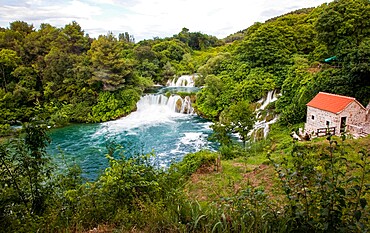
[47,88,216,180]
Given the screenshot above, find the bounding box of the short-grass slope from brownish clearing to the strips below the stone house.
[185,125,370,203]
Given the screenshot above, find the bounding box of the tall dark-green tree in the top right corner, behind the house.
[315,0,370,104]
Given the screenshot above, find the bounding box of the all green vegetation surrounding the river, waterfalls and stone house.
[0,0,370,232]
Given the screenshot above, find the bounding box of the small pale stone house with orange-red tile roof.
[305,92,370,137]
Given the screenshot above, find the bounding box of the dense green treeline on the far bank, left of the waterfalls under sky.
[0,21,222,133]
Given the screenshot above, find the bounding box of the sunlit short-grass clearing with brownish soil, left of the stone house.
[185,124,292,203]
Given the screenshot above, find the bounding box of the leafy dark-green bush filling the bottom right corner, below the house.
[270,137,370,232]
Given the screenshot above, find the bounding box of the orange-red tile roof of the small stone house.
[307,92,364,114]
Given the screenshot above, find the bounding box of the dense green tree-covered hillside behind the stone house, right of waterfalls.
[196,0,370,125]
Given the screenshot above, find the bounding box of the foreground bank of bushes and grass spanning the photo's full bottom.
[0,123,370,232]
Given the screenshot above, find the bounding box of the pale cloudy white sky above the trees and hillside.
[0,0,331,42]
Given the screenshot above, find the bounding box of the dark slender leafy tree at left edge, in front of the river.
[0,123,51,231]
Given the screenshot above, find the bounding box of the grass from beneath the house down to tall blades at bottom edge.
[83,128,370,232]
